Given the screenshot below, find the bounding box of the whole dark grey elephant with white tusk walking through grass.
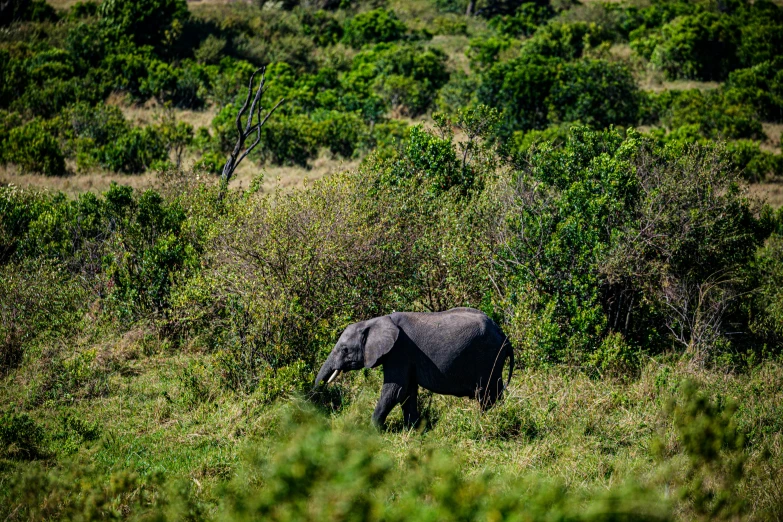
[315,308,514,427]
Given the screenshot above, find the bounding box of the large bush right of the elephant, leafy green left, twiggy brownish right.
[495,128,768,364]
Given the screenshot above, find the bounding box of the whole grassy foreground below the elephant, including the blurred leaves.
[0,335,783,520]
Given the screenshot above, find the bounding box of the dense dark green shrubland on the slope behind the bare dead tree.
[0,0,783,176]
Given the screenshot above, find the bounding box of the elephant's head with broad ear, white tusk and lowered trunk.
[315,315,400,386]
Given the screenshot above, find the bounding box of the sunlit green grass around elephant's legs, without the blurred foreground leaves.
[0,328,783,520]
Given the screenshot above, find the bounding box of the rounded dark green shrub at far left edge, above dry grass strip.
[3,119,65,176]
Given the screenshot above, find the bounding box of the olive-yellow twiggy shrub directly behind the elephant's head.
[168,171,420,391]
